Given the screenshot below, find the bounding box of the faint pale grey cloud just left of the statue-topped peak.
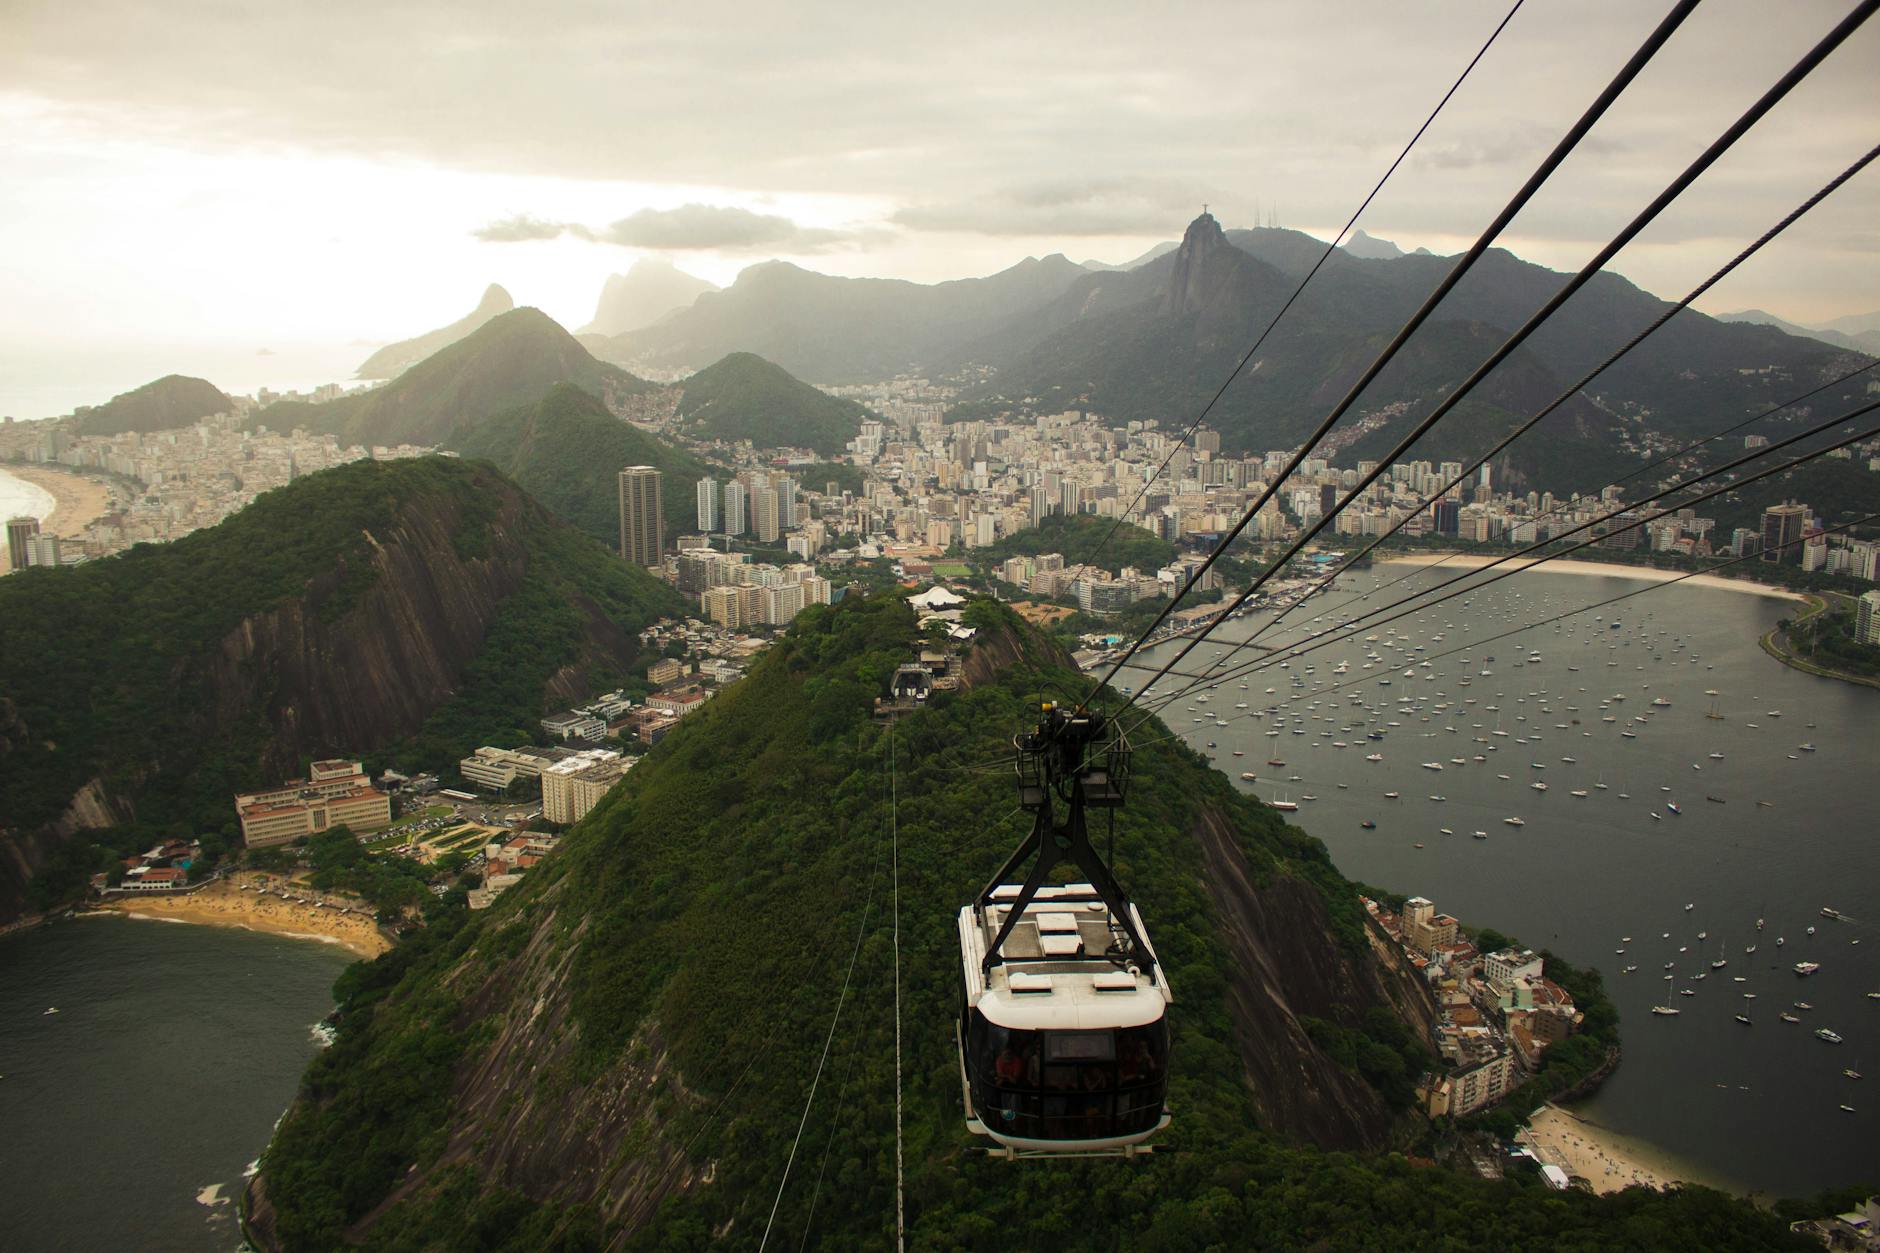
[893,179,1207,235]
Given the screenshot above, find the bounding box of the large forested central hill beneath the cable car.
[248,596,1807,1253]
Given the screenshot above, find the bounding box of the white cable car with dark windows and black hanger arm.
[959,704,1175,1159]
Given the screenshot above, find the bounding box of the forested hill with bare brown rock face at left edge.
[0,457,679,922]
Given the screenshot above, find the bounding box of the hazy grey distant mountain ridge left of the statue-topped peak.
[600,254,1085,384]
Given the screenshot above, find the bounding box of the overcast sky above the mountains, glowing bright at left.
[0,0,1880,410]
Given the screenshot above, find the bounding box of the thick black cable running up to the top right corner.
[1105,0,1880,707]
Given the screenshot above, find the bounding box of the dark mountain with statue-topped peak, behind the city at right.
[951,216,1859,489]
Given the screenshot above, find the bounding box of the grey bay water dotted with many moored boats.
[1122,566,1880,1195]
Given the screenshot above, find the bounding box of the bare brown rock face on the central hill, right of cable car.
[1194,809,1434,1150]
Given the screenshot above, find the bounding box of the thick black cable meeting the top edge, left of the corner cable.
[1079,0,1699,711]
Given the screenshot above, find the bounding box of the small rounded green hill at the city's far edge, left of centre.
[679,352,869,455]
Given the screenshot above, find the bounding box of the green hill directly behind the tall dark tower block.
[447,384,722,547]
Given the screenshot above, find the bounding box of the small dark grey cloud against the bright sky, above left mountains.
[470,203,861,256]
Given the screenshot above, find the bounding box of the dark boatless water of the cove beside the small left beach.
[0,906,352,1253]
